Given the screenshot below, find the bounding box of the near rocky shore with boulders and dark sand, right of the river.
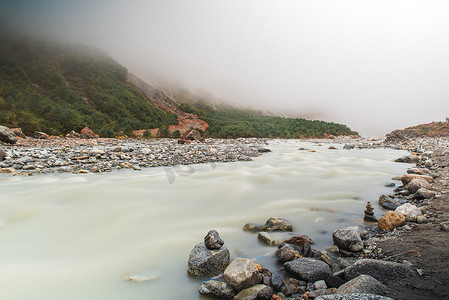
[188,138,449,300]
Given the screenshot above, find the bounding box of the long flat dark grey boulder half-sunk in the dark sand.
[344,259,416,282]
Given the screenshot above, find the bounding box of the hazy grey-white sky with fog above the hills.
[0,0,449,136]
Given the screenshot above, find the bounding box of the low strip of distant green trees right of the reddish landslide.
[180,101,357,138]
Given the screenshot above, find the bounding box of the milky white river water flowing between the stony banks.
[0,140,410,300]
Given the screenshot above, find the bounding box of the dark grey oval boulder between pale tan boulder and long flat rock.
[284,257,332,282]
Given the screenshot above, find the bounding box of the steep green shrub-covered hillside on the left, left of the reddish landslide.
[0,33,177,137]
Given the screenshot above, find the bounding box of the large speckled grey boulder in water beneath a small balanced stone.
[187,243,230,277]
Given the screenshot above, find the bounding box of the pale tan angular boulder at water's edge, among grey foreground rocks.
[224,258,263,291]
